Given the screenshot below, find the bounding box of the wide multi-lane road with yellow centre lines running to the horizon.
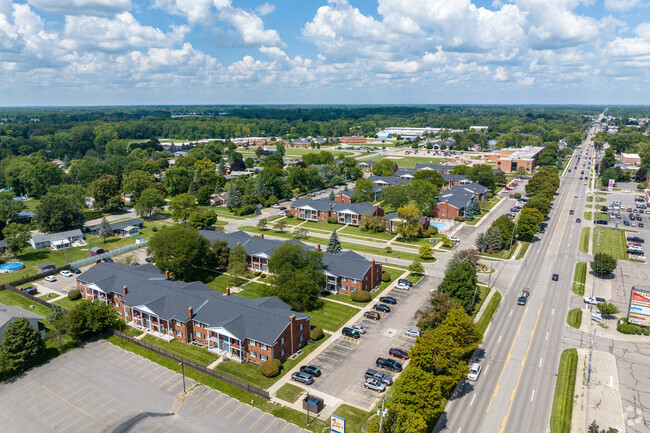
[434,120,595,433]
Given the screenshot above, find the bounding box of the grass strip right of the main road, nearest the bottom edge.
[551,349,578,433]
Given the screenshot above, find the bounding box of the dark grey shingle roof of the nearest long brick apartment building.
[77,263,309,345]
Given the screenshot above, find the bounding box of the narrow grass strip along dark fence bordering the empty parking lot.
[107,336,325,433]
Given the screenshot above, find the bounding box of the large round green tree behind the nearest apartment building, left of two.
[147,225,213,281]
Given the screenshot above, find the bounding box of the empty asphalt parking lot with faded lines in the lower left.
[0,341,301,433]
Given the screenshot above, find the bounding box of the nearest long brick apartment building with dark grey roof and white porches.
[77,263,310,364]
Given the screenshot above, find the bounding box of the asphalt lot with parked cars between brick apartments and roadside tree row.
[299,277,426,410]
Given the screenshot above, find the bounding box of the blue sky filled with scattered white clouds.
[0,0,650,106]
